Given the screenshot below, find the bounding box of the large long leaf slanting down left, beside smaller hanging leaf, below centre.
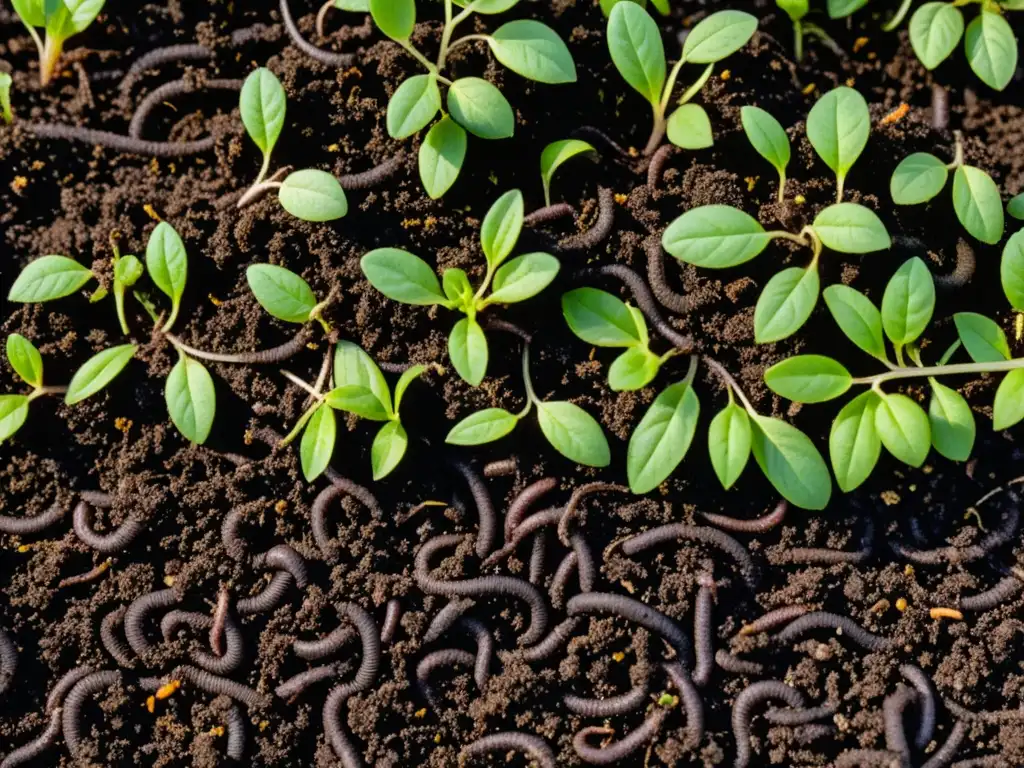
[626,382,700,494]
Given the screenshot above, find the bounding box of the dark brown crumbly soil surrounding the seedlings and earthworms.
[0,0,1024,766]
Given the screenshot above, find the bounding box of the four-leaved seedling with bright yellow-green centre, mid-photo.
[359,189,559,387]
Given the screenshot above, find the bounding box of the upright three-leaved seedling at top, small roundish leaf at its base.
[607,2,758,155]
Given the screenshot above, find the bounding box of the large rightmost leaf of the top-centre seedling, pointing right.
[487,19,577,85]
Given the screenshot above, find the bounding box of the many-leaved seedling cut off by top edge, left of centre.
[370,0,577,200]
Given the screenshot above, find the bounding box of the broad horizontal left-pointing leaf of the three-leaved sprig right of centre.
[662,205,771,269]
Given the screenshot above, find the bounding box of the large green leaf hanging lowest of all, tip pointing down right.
[751,416,831,510]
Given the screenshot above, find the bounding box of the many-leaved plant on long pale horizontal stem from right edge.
[765,252,1024,492]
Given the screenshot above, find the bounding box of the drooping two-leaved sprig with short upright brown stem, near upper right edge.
[889,131,1006,245]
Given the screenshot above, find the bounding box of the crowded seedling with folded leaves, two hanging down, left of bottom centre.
[282,341,427,482]
